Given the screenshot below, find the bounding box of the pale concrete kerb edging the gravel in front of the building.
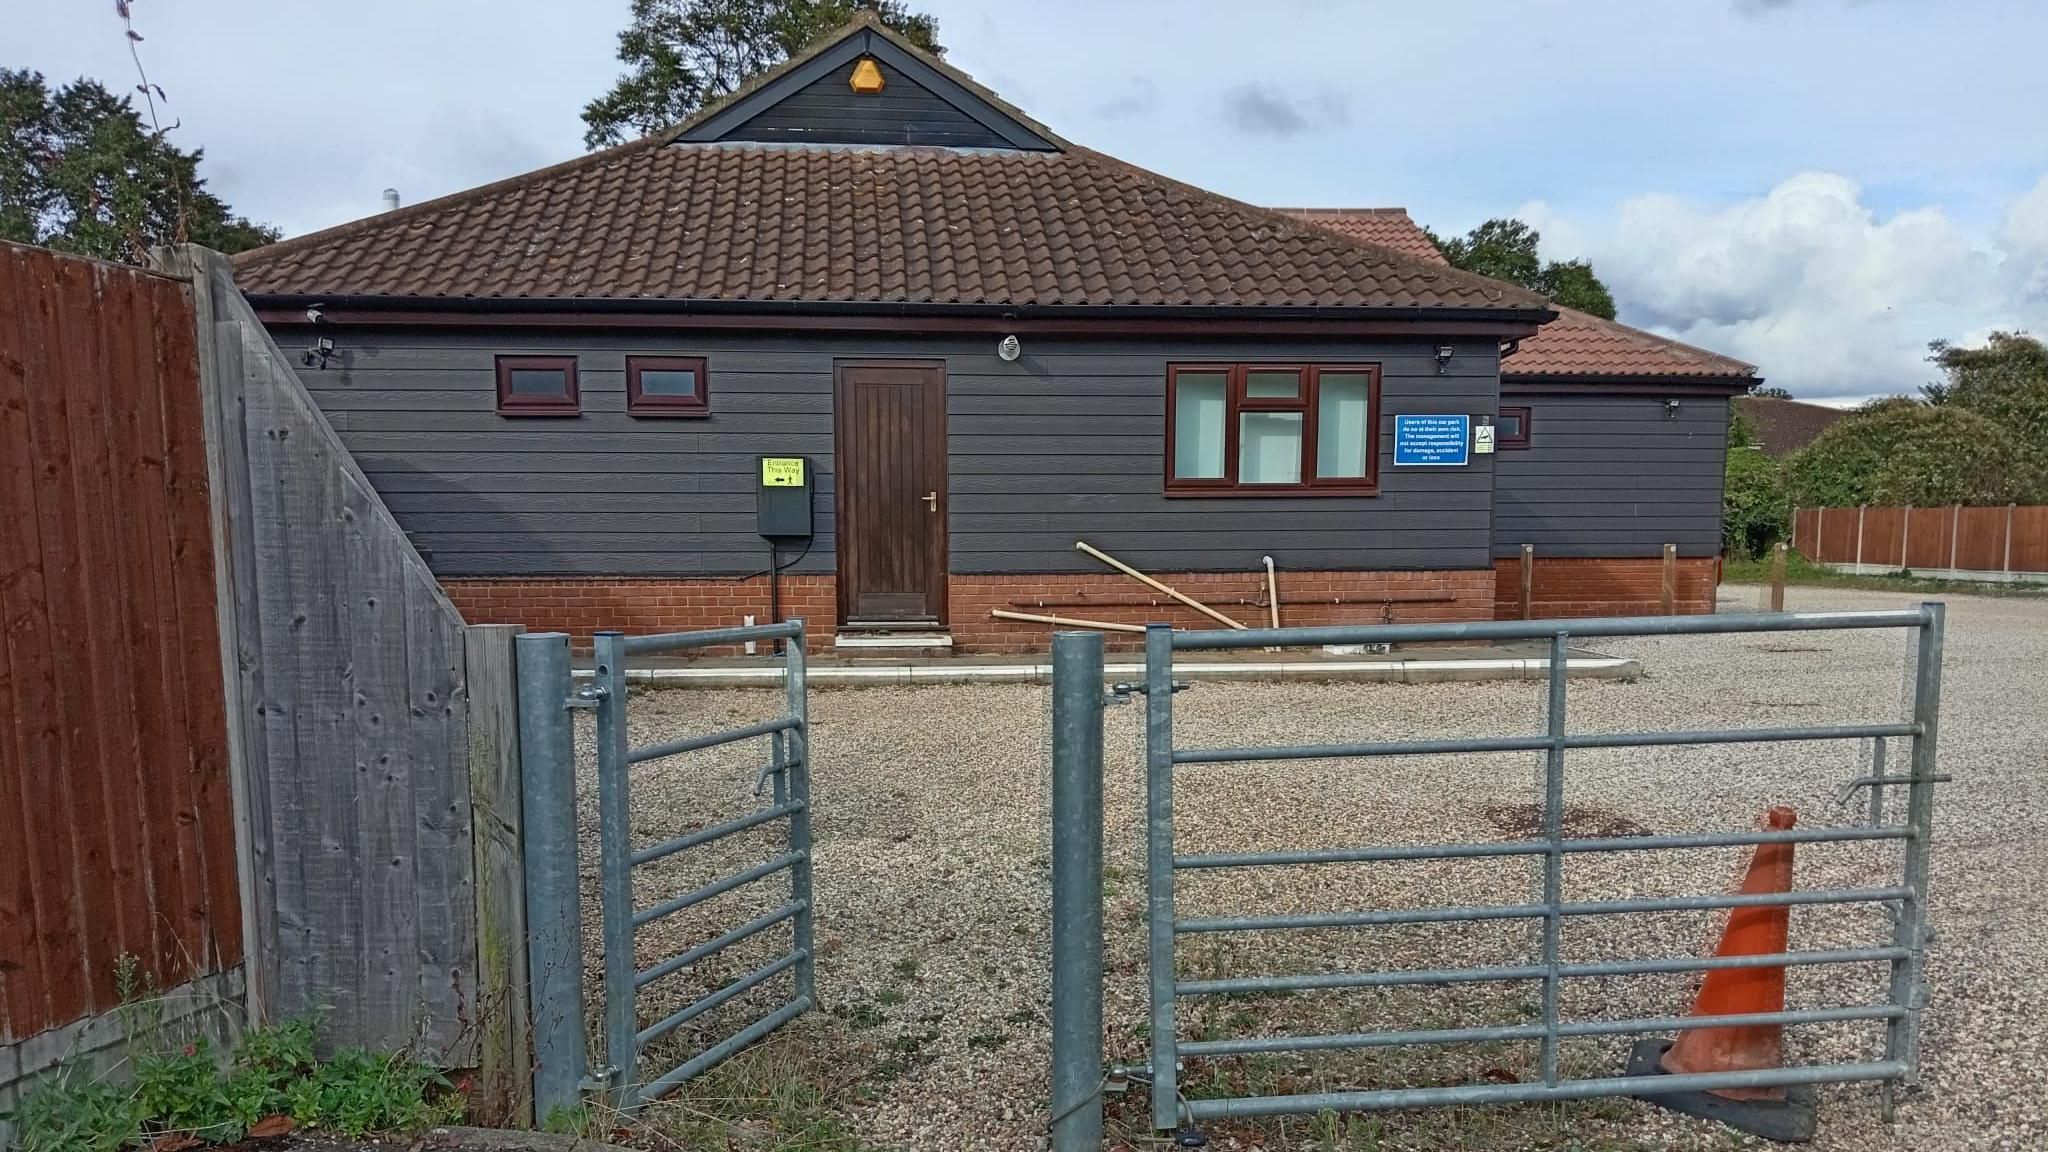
[575,650,1642,689]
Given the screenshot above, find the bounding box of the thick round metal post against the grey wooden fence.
[514,631,590,1123]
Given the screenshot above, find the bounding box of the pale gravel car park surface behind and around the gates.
[580,588,2048,1152]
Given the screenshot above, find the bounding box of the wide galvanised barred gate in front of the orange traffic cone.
[1055,603,1942,1127]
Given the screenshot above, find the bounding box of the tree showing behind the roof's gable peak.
[584,0,946,148]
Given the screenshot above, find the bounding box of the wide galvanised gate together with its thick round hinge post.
[1053,603,1944,1152]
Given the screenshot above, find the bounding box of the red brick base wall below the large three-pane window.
[948,570,1493,654]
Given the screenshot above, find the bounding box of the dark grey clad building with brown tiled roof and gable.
[236,20,1751,650]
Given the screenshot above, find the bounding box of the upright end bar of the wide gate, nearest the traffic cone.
[1884,603,1944,1082]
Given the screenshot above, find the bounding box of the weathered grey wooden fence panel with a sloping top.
[168,248,477,1066]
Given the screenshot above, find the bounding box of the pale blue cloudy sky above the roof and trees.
[16,0,2048,404]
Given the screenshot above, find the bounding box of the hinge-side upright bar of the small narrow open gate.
[592,631,639,1111]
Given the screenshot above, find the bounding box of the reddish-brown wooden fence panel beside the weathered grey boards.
[0,244,242,1043]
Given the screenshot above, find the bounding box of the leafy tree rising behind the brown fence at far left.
[0,68,279,264]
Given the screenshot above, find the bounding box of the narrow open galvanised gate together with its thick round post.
[520,621,817,1119]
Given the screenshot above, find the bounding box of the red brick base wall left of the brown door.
[440,572,840,648]
